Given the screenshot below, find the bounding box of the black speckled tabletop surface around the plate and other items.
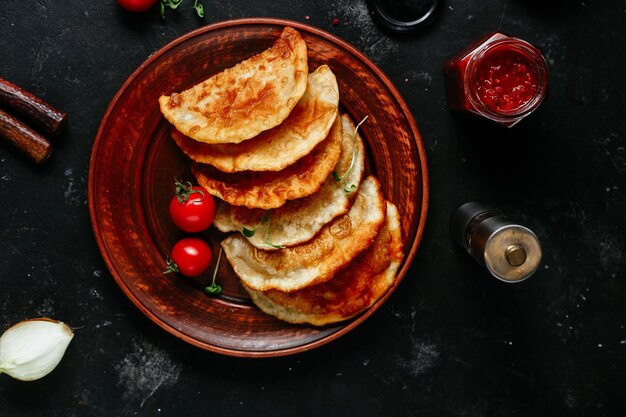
[0,0,626,417]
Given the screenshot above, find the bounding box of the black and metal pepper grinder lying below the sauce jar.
[450,201,541,283]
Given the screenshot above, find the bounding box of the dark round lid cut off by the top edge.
[367,0,440,33]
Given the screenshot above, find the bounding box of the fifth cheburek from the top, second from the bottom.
[222,176,386,292]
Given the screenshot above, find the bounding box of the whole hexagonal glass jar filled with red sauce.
[445,32,548,127]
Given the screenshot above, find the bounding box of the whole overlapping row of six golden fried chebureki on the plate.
[159,27,403,326]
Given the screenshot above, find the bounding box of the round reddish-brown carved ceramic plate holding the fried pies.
[89,19,428,357]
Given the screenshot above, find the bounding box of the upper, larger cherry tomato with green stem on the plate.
[169,182,216,233]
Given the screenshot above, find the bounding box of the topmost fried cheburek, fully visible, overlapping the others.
[159,27,308,143]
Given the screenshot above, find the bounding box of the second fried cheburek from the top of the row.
[172,65,339,173]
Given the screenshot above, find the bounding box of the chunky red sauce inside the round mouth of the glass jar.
[474,44,539,113]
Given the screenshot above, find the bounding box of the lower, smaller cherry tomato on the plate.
[165,237,212,277]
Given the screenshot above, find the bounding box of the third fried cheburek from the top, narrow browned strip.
[191,118,343,209]
